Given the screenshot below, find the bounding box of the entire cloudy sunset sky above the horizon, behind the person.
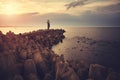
[0,0,120,27]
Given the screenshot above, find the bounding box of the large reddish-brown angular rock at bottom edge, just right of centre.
[56,61,79,80]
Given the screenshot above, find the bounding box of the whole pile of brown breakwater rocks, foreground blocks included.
[0,29,120,80]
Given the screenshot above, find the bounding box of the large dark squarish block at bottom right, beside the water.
[89,64,107,80]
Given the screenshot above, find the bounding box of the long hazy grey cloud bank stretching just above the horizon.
[0,12,120,27]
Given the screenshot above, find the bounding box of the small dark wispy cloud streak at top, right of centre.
[65,0,88,10]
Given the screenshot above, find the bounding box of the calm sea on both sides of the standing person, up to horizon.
[0,26,120,72]
